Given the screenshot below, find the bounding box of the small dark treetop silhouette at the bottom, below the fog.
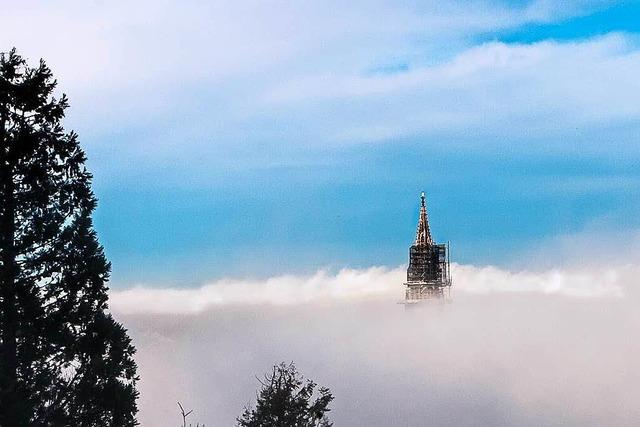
[237,363,333,427]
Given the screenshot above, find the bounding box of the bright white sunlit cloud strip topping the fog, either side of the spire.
[110,264,631,314]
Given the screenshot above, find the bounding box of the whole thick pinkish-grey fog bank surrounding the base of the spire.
[111,265,640,427]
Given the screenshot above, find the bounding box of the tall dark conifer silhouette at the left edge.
[0,49,137,427]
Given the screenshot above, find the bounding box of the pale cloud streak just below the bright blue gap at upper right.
[265,34,640,144]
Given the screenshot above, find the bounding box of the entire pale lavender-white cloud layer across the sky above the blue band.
[0,0,624,148]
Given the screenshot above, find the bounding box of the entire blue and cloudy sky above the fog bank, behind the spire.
[5,0,640,287]
